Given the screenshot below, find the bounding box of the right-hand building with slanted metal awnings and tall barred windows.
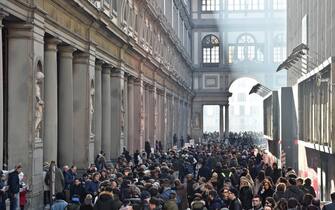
[277,0,335,200]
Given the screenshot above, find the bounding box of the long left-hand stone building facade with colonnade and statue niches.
[0,0,193,209]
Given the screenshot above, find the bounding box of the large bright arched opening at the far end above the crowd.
[229,77,263,132]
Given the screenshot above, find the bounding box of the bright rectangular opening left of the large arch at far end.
[203,105,220,133]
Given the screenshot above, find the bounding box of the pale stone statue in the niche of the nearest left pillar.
[35,71,44,138]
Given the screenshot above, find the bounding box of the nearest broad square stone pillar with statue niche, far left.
[7,22,44,209]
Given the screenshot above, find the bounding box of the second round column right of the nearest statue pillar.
[58,46,75,166]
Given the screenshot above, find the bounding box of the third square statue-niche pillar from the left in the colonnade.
[111,69,125,158]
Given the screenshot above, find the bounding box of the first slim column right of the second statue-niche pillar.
[94,61,103,157]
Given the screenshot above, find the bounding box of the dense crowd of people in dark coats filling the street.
[0,133,335,210]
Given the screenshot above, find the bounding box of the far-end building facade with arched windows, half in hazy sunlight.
[191,0,286,141]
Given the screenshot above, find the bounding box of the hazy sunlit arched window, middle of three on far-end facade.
[237,34,256,61]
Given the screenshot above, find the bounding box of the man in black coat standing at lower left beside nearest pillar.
[7,164,22,210]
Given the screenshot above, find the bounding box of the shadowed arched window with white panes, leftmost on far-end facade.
[202,34,220,63]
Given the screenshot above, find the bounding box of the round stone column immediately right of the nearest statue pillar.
[43,38,60,163]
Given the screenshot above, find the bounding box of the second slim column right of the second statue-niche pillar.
[101,64,112,160]
